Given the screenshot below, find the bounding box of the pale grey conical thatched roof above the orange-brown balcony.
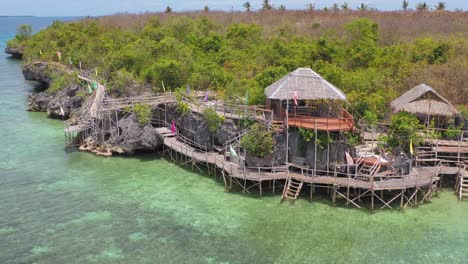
[265,68,346,101]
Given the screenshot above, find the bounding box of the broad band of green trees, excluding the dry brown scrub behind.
[11,13,468,121]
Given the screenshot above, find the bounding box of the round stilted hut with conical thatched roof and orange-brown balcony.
[265,68,354,131]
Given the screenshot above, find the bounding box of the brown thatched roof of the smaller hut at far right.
[391,84,460,117]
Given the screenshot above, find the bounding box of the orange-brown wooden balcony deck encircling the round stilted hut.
[288,116,354,132]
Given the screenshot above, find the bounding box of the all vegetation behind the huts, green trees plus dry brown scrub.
[10,11,468,120]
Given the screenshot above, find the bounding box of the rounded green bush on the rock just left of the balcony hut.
[240,123,275,158]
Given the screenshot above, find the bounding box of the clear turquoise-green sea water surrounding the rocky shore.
[0,17,468,264]
